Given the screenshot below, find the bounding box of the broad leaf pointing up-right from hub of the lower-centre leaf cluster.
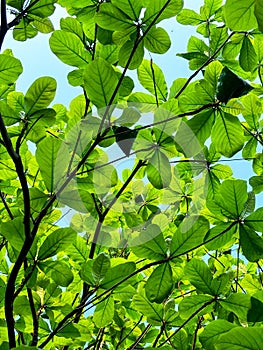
[170,216,209,256]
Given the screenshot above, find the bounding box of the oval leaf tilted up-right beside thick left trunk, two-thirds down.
[38,228,76,260]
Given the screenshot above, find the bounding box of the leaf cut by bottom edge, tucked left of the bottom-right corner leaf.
[199,320,237,350]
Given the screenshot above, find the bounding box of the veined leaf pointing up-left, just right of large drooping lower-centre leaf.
[185,259,214,295]
